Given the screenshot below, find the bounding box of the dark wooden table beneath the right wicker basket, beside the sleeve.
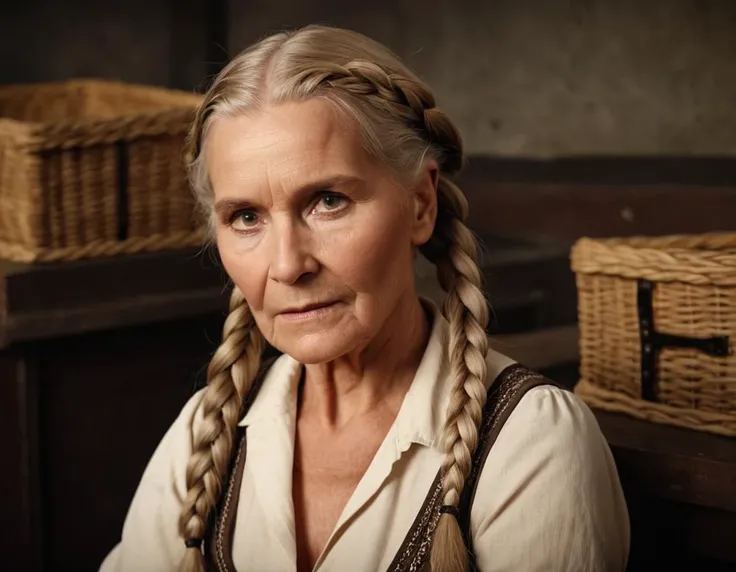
[596,411,736,571]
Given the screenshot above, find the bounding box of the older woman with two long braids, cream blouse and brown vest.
[102,26,629,572]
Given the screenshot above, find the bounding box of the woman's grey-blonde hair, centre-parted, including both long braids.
[180,26,489,572]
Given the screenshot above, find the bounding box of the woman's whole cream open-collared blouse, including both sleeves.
[100,307,629,572]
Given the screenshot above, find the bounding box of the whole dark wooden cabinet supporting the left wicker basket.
[0,252,226,571]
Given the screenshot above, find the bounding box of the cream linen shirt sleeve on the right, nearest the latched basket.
[471,386,629,572]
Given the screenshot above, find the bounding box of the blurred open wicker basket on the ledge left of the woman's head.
[0,80,202,262]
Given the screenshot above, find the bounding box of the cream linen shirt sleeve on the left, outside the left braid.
[100,391,202,572]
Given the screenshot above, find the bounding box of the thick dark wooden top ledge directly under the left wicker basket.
[0,250,227,347]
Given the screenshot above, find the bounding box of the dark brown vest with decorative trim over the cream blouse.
[204,362,555,572]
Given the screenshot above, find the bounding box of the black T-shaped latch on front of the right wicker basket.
[637,280,729,401]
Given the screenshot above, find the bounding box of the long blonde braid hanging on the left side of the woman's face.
[179,287,264,572]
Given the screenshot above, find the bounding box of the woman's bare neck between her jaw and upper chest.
[299,296,431,429]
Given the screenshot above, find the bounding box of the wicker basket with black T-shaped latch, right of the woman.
[572,233,736,436]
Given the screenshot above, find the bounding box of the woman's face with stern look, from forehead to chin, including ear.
[206,99,437,363]
